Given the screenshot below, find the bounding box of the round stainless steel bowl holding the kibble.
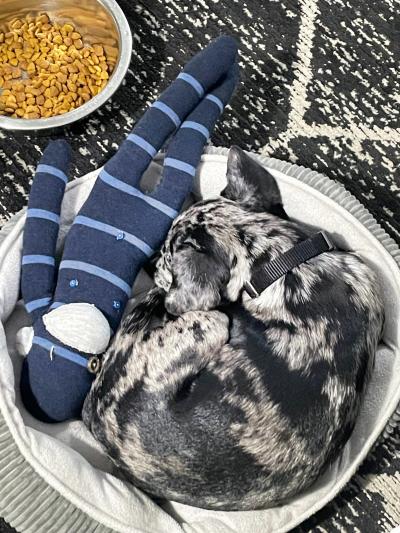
[0,0,132,131]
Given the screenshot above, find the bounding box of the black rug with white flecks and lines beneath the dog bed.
[0,0,400,533]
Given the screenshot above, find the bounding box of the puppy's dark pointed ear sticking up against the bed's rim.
[221,146,288,219]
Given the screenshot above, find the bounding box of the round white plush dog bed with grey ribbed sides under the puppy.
[0,148,400,533]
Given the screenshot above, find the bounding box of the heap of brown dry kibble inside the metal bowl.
[0,13,114,119]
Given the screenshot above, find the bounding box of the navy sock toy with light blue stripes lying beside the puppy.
[20,36,238,423]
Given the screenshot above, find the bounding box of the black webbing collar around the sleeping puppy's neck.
[244,231,335,298]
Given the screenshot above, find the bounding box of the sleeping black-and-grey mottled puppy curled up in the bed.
[83,147,383,510]
